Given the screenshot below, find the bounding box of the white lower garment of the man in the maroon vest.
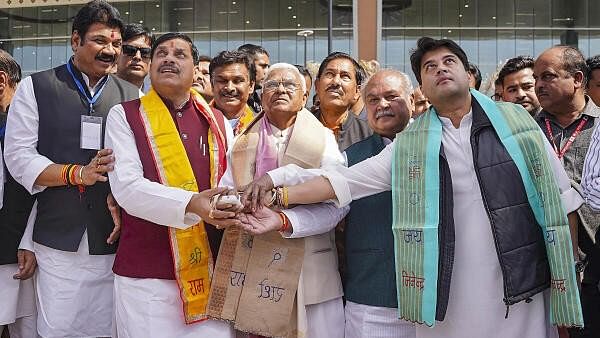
[115,275,236,338]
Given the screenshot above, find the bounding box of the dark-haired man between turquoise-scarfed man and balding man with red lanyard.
[498,55,541,116]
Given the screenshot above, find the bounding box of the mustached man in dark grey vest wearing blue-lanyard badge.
[5,1,139,337]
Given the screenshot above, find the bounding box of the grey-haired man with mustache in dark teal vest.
[234,69,415,338]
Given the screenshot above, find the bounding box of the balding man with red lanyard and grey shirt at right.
[533,46,600,337]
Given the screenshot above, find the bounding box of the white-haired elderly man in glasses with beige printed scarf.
[209,63,345,338]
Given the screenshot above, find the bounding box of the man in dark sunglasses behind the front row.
[117,23,154,90]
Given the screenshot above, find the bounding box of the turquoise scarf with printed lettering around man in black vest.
[392,90,583,327]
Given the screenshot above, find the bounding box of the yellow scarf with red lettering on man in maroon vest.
[140,89,226,324]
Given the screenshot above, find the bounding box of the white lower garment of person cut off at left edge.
[0,264,37,338]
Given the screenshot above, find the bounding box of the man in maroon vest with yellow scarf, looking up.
[106,33,238,338]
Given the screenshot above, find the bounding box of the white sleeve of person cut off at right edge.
[581,121,600,210]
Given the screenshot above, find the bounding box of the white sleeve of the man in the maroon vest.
[105,104,200,229]
